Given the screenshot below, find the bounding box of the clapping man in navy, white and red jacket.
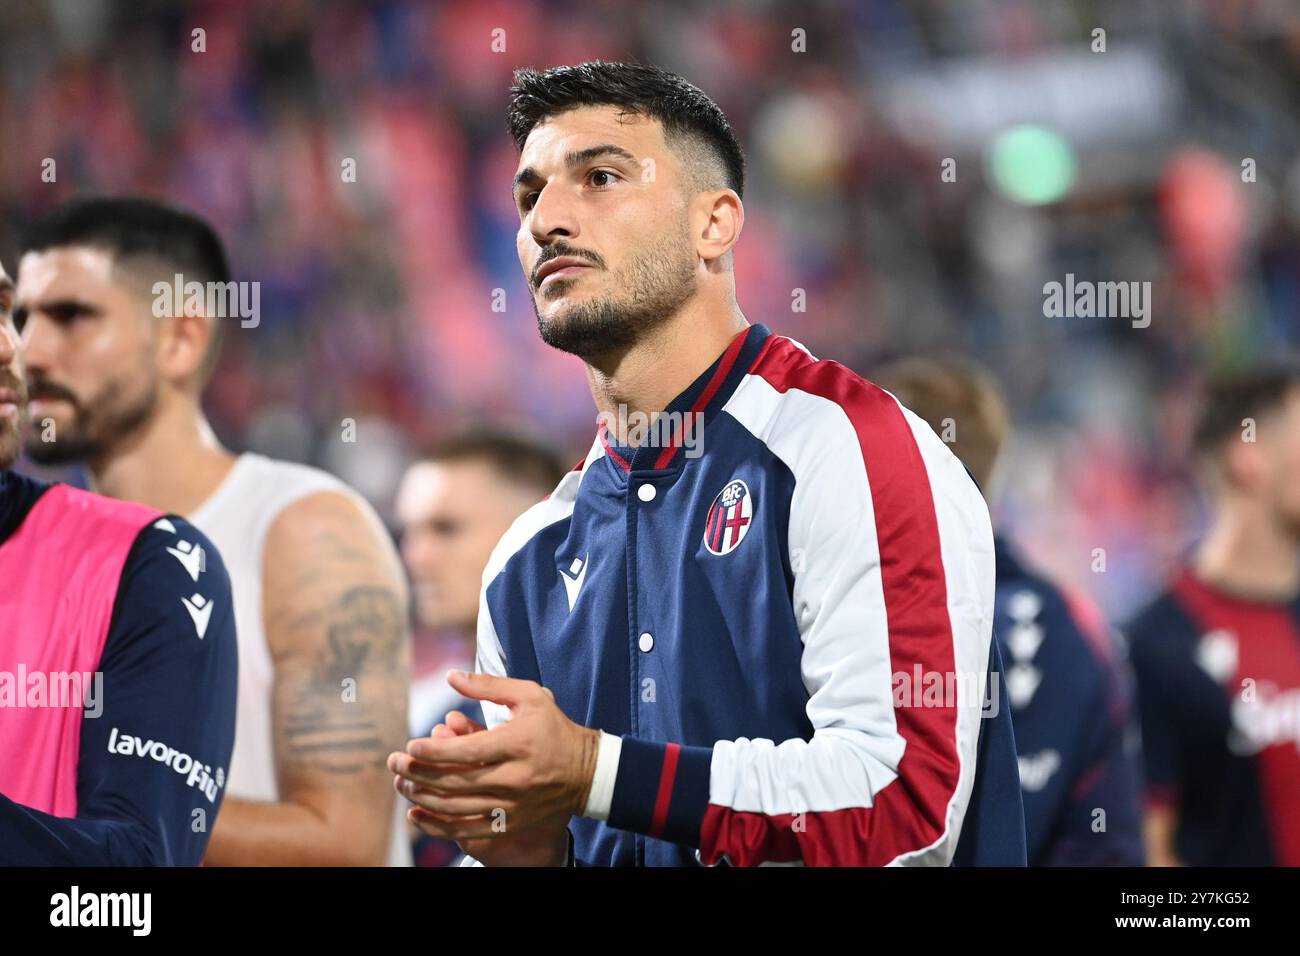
[390,61,1024,865]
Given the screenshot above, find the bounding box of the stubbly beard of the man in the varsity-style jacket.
[533,232,697,359]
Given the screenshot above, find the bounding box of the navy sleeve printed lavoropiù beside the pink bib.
[0,516,238,866]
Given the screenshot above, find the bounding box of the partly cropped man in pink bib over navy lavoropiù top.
[0,256,238,866]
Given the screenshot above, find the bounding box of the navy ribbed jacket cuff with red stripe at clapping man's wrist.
[593,736,714,847]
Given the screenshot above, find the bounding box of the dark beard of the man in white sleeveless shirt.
[26,369,159,464]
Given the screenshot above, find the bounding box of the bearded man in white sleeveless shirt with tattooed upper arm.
[14,199,410,865]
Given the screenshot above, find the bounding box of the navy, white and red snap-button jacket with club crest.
[477,325,1024,865]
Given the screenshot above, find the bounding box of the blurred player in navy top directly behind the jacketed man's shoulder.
[871,359,1143,866]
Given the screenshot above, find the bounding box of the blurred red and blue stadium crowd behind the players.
[0,0,1300,619]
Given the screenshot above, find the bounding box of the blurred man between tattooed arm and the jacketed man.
[395,432,564,866]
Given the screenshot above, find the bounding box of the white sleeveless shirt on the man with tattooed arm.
[189,453,411,866]
